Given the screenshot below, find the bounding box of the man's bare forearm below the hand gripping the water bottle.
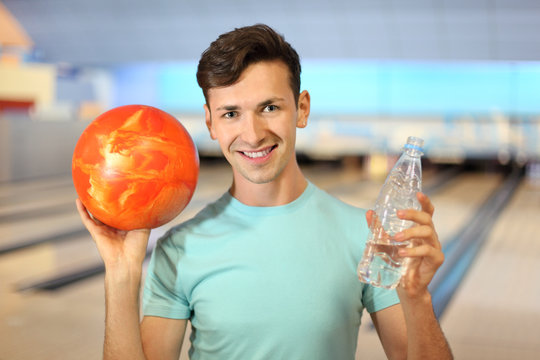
[401,293,453,360]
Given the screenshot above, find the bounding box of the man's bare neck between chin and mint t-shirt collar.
[229,161,307,206]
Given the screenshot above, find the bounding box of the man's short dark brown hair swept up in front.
[197,24,301,105]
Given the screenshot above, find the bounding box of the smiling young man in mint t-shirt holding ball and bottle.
[77,25,452,360]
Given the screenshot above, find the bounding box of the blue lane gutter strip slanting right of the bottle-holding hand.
[429,169,523,317]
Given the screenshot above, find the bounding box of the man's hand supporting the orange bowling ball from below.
[76,199,150,267]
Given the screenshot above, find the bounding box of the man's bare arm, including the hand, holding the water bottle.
[368,193,453,360]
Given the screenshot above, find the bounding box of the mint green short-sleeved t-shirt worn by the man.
[143,183,399,360]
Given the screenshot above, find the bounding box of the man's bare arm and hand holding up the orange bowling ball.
[77,199,186,360]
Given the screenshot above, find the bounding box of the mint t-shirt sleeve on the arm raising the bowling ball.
[142,237,191,319]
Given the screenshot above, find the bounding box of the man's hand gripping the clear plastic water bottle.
[394,193,444,299]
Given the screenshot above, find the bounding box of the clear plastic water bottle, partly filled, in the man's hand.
[358,136,424,289]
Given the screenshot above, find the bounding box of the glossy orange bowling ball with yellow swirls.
[72,105,199,230]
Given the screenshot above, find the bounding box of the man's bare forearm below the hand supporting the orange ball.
[103,267,145,360]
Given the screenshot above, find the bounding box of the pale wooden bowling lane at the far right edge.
[442,181,540,360]
